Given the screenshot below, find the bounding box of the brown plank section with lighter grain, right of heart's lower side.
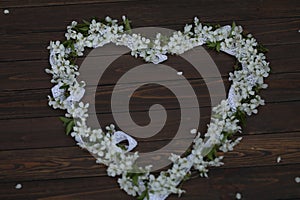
[223,132,300,168]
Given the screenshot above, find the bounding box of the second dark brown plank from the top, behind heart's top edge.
[0,18,300,61]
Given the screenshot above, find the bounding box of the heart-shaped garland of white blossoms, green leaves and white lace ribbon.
[46,16,270,199]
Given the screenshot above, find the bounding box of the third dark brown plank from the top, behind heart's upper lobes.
[0,44,300,91]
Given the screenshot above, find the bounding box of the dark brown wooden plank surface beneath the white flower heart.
[0,0,300,200]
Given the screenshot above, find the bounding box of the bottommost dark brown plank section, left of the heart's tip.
[0,177,132,200]
